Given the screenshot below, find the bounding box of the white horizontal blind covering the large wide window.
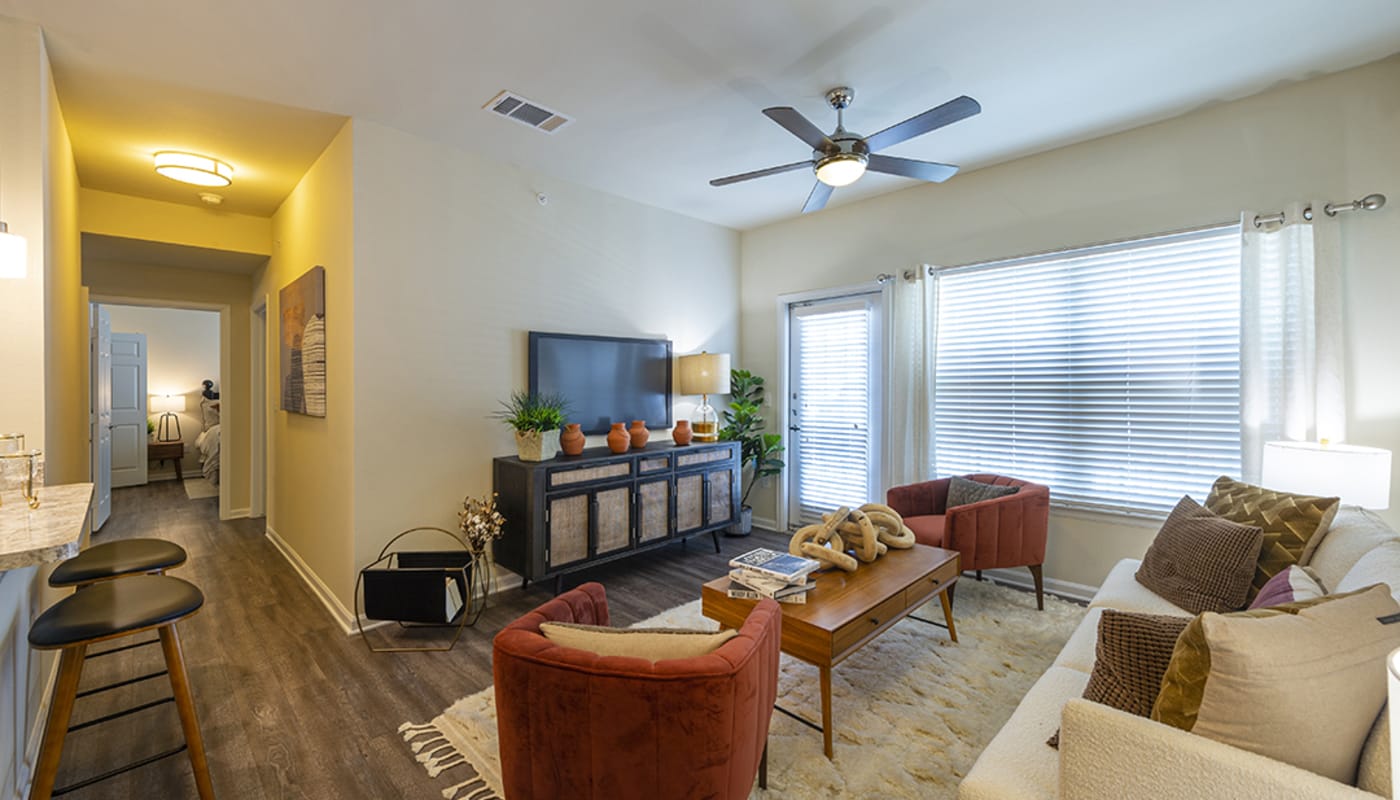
[932,226,1240,511]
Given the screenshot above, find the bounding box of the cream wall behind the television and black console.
[352,120,739,588]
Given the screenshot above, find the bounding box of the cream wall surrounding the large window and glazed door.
[741,50,1400,586]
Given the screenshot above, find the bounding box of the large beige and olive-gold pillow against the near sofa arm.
[1152,586,1400,785]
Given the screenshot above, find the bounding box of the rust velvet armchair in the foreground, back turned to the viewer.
[493,583,783,800]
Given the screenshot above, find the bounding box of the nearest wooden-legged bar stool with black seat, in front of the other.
[29,577,214,800]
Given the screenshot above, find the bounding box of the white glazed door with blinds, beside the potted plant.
[788,293,883,528]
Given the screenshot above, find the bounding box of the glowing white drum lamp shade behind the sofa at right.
[1263,441,1390,509]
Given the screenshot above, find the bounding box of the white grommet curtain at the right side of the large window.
[1239,202,1347,483]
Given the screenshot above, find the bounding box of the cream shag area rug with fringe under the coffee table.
[399,577,1085,800]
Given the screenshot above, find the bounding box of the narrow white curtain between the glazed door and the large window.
[885,265,937,488]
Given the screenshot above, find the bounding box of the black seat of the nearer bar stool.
[29,574,204,649]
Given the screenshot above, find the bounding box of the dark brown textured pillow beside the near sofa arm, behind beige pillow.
[1046,608,1191,748]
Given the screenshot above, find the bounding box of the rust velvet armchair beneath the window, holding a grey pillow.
[885,474,1050,611]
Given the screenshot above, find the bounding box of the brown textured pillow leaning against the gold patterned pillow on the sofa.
[1137,497,1264,614]
